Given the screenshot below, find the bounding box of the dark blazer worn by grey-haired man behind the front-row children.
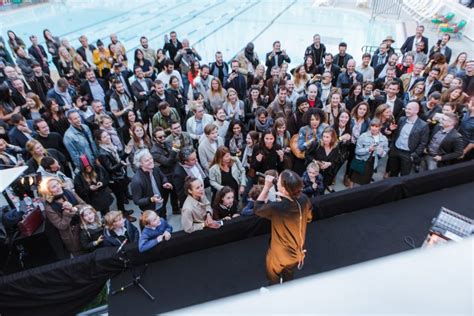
[131,167,168,211]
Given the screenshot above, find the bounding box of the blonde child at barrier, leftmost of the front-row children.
[76,204,104,252]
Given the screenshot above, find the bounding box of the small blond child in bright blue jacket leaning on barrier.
[138,211,173,252]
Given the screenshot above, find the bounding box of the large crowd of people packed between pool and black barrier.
[0,25,474,256]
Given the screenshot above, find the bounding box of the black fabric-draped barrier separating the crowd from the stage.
[0,161,474,315]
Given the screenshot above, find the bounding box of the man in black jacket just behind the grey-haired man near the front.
[151,127,180,214]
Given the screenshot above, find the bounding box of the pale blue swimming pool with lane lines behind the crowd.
[0,0,404,64]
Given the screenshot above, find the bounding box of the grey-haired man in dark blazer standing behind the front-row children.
[131,149,173,219]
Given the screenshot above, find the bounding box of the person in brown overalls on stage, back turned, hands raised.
[254,170,312,285]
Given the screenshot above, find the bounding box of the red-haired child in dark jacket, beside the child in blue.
[104,211,139,247]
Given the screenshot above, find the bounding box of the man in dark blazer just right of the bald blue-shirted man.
[423,113,464,170]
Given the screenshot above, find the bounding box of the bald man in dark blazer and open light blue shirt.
[387,102,429,177]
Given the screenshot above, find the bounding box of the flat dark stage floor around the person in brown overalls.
[108,183,474,316]
